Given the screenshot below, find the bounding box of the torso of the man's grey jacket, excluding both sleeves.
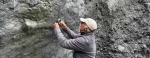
[73,34,96,58]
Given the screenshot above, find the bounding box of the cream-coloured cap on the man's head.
[80,18,97,31]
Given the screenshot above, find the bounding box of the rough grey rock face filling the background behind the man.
[0,0,150,58]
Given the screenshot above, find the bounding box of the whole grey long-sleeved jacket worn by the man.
[54,27,96,58]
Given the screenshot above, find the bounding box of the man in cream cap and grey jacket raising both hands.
[53,18,97,58]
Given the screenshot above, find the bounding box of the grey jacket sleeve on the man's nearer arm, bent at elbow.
[54,28,87,51]
